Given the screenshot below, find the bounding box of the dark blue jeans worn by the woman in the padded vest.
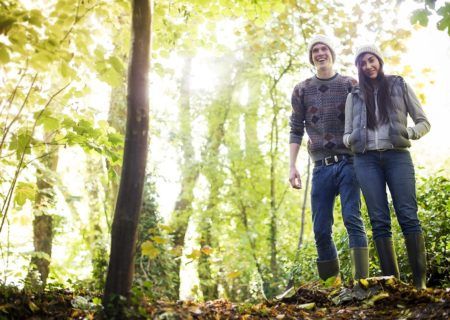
[354,150,422,240]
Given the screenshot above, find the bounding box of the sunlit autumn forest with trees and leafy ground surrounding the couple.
[0,0,450,319]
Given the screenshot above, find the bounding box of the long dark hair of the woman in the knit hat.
[356,54,392,129]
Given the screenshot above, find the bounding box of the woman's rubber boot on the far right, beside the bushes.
[405,233,427,289]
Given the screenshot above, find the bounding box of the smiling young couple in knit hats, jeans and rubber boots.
[289,35,430,289]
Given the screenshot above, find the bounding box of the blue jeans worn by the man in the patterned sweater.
[311,159,367,261]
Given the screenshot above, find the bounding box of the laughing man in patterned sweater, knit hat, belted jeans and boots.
[289,35,369,280]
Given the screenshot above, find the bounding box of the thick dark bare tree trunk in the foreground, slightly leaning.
[103,0,151,309]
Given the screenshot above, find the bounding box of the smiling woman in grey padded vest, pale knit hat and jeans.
[343,45,430,289]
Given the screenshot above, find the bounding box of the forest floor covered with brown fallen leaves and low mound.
[0,277,450,320]
